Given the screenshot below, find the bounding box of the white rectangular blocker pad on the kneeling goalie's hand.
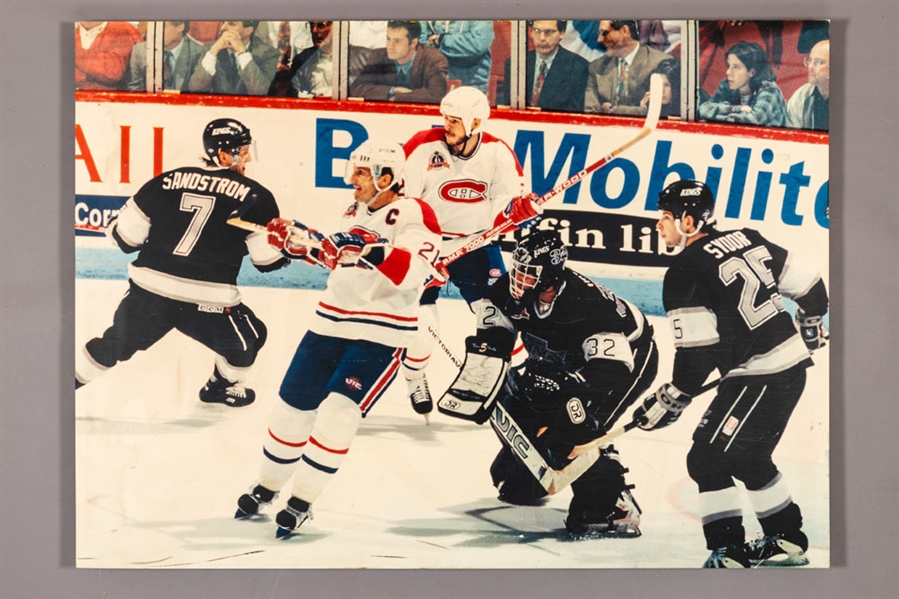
[437,337,512,424]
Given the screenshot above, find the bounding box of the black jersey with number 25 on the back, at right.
[663,229,820,394]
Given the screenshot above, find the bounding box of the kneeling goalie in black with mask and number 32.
[438,231,658,537]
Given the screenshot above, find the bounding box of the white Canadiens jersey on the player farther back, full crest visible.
[403,127,524,255]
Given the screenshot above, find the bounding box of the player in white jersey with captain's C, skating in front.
[235,140,440,537]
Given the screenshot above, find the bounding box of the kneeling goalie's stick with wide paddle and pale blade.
[428,326,599,495]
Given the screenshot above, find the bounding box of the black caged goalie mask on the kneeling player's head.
[509,229,568,299]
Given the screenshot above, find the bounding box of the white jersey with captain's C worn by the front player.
[309,198,440,348]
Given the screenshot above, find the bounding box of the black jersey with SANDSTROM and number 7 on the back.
[109,167,281,305]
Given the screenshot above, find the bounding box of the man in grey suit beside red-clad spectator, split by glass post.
[128,21,205,92]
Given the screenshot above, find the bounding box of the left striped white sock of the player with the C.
[259,401,316,491]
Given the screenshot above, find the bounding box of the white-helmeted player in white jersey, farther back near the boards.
[403,87,540,414]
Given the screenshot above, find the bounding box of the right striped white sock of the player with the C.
[293,393,362,503]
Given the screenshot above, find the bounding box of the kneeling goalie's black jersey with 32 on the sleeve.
[477,269,652,382]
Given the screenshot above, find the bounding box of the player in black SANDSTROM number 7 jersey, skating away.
[75,119,288,407]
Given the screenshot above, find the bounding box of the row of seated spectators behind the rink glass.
[75,19,830,131]
